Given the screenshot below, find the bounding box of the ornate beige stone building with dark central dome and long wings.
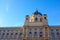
[0,10,60,40]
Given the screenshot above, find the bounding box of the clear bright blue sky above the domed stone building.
[0,0,60,27]
